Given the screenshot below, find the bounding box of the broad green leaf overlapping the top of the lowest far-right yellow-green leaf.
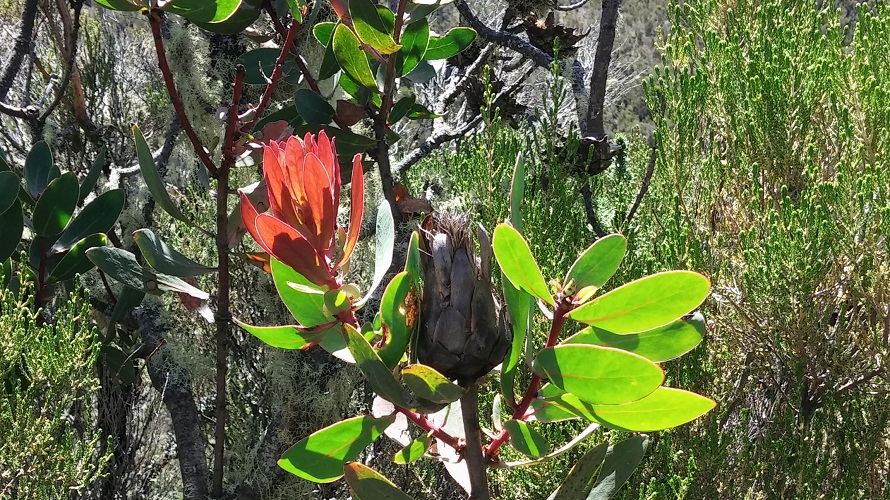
[534,344,664,404]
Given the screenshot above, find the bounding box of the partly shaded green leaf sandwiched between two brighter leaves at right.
[562,313,705,363]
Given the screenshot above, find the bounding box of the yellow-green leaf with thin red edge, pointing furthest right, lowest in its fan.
[591,387,717,432]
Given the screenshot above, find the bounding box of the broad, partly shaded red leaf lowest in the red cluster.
[248,214,336,286]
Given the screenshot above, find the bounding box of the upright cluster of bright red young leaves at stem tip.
[241,131,365,288]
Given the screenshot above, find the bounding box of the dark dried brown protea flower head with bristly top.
[417,214,510,386]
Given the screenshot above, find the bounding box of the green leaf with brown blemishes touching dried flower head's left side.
[377,271,418,369]
